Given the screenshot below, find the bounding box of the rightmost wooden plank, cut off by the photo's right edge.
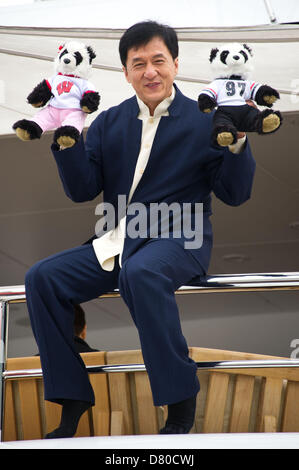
[281,381,299,432]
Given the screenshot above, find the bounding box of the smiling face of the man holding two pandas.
[123,37,178,114]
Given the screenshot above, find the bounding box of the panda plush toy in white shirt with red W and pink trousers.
[13,41,100,148]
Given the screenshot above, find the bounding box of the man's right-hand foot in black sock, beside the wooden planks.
[159,396,196,434]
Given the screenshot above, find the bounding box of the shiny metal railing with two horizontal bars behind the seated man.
[0,272,299,441]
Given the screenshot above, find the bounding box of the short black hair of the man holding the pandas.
[119,21,179,67]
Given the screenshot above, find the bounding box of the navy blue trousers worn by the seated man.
[25,239,202,406]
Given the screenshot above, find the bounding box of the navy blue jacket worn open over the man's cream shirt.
[52,86,255,272]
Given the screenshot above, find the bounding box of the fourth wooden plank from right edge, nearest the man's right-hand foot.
[203,372,229,433]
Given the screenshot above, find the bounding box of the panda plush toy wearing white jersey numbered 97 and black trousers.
[198,43,282,147]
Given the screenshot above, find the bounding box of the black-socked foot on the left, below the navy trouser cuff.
[45,400,91,439]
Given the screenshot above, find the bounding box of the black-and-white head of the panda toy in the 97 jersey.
[210,43,253,80]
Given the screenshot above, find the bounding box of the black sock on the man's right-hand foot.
[166,396,196,432]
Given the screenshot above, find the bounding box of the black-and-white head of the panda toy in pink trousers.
[54,41,95,79]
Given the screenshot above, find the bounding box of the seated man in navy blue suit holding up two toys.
[25,21,255,438]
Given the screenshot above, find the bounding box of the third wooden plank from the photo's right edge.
[229,375,254,432]
